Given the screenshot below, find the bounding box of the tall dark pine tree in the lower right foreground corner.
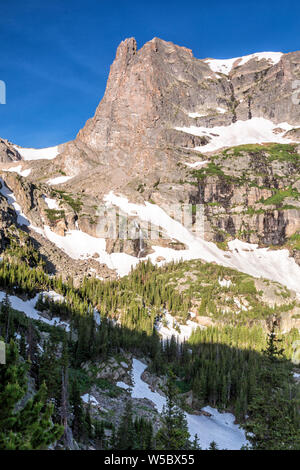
[244,324,300,450]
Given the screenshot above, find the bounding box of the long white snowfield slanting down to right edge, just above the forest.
[104,192,300,293]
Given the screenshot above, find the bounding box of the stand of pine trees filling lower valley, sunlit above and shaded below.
[0,239,300,449]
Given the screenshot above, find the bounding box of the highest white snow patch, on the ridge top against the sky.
[204,52,283,75]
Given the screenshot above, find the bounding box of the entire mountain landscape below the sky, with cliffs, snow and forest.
[0,38,300,450]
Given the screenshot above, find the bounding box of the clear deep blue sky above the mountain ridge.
[0,0,300,147]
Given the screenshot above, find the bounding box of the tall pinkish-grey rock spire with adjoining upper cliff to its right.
[58,38,300,177]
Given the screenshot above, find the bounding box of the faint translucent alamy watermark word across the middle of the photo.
[96,204,204,240]
